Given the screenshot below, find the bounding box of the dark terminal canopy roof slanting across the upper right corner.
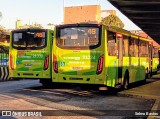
[108,0,160,44]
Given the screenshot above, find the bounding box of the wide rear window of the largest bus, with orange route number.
[56,27,99,48]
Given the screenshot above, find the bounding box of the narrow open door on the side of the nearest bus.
[116,33,123,84]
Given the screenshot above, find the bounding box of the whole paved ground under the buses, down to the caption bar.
[0,74,160,119]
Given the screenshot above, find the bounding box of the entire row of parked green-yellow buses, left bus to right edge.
[9,24,159,89]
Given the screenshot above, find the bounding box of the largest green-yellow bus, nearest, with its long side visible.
[52,24,151,89]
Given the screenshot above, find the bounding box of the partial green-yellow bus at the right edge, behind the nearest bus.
[152,46,159,74]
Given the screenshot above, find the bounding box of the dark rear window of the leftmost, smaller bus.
[12,31,46,50]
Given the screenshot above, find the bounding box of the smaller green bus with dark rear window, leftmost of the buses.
[9,28,53,83]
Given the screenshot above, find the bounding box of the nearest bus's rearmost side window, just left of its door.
[107,31,118,56]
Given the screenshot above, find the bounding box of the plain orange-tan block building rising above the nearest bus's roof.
[64,5,101,24]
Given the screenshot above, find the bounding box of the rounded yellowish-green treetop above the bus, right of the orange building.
[101,15,124,28]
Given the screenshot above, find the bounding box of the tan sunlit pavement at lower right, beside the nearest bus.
[118,72,160,119]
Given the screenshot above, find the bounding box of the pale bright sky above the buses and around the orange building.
[0,0,140,30]
